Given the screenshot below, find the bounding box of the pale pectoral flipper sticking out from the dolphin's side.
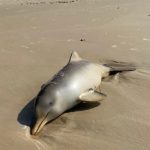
[79,90,106,102]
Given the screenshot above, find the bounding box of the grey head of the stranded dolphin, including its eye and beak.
[31,85,61,135]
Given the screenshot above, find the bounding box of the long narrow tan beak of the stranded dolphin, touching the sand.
[30,113,48,135]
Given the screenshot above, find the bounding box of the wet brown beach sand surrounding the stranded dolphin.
[0,0,150,150]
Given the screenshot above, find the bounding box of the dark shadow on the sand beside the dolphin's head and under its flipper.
[17,98,100,128]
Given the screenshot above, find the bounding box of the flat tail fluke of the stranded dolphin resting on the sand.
[103,61,136,75]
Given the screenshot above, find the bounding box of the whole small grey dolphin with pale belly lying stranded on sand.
[31,52,135,135]
